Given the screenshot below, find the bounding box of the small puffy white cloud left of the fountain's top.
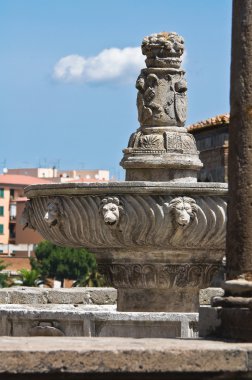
[53,47,145,82]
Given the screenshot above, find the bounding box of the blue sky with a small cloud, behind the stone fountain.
[0,0,231,179]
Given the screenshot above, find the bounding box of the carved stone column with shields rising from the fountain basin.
[121,33,202,182]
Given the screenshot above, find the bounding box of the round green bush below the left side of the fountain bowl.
[31,241,102,286]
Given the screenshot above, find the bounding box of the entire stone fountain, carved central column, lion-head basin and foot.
[24,33,227,313]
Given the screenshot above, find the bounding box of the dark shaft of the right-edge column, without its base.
[227,0,252,281]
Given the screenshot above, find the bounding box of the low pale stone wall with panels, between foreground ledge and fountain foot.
[0,304,198,338]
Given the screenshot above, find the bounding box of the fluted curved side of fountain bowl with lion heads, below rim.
[24,184,226,252]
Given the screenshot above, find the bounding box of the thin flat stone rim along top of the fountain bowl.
[24,181,228,198]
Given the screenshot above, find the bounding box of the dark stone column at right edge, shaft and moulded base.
[199,0,252,341]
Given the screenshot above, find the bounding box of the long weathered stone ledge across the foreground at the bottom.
[0,337,252,379]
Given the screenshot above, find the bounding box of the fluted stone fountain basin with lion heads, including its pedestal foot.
[23,181,227,312]
